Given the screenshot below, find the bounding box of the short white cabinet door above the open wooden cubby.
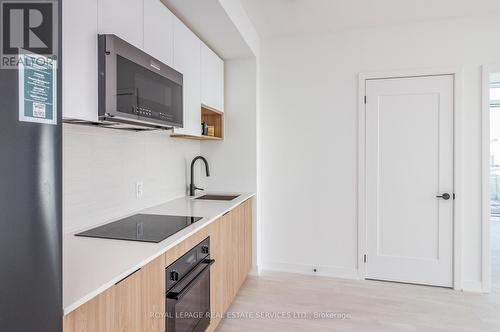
[201,43,224,111]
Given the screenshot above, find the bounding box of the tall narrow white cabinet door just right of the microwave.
[174,18,201,135]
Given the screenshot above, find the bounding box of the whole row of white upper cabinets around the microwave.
[62,0,224,131]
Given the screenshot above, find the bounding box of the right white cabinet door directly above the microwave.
[144,0,174,67]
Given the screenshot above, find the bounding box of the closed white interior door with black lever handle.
[366,75,454,287]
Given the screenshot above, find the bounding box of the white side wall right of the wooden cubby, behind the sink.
[201,58,260,267]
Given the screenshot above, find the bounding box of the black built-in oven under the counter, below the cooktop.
[165,237,215,332]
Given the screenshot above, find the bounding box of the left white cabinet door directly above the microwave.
[97,0,144,50]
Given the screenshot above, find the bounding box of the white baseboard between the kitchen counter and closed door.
[263,262,359,279]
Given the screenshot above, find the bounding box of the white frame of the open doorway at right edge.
[481,64,500,293]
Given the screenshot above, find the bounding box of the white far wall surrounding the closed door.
[259,13,500,289]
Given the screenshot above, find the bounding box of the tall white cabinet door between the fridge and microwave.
[62,0,97,121]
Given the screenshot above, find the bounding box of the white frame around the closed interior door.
[357,67,463,290]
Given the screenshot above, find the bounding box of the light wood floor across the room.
[218,272,500,332]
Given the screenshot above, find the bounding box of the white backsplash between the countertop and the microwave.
[63,124,200,233]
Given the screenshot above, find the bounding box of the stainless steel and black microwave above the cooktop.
[98,34,183,128]
